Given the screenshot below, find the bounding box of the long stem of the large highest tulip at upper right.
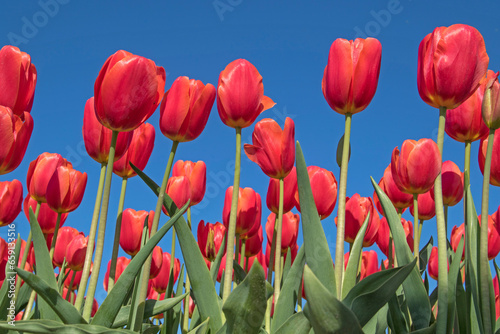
[434,107,448,333]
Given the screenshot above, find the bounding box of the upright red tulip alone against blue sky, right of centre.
[322,38,382,114]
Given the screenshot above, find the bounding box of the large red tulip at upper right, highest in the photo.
[417,24,489,109]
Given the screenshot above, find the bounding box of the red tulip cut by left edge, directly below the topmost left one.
[0,107,33,175]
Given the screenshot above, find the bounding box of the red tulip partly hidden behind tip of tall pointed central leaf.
[295,166,337,219]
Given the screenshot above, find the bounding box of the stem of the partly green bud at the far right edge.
[478,129,495,333]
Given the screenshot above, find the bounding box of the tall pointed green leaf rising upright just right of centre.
[296,141,336,297]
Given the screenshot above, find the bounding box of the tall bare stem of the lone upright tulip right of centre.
[335,113,352,298]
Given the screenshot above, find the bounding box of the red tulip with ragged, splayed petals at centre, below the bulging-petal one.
[244,117,295,179]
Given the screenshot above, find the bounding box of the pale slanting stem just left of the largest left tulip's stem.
[75,162,106,311]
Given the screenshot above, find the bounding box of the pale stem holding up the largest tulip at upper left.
[82,131,118,321]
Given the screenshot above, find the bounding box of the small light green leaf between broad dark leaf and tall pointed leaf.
[271,247,305,332]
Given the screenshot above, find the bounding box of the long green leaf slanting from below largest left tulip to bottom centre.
[131,163,223,332]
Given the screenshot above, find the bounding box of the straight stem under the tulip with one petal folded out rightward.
[222,128,241,305]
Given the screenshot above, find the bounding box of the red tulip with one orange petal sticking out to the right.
[217,59,275,128]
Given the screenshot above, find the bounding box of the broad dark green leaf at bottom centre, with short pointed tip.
[222,261,267,334]
